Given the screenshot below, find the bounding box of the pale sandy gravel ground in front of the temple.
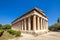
[8,32,60,40]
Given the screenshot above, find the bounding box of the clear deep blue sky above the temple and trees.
[0,0,60,25]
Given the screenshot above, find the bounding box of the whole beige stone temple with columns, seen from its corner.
[12,8,48,33]
